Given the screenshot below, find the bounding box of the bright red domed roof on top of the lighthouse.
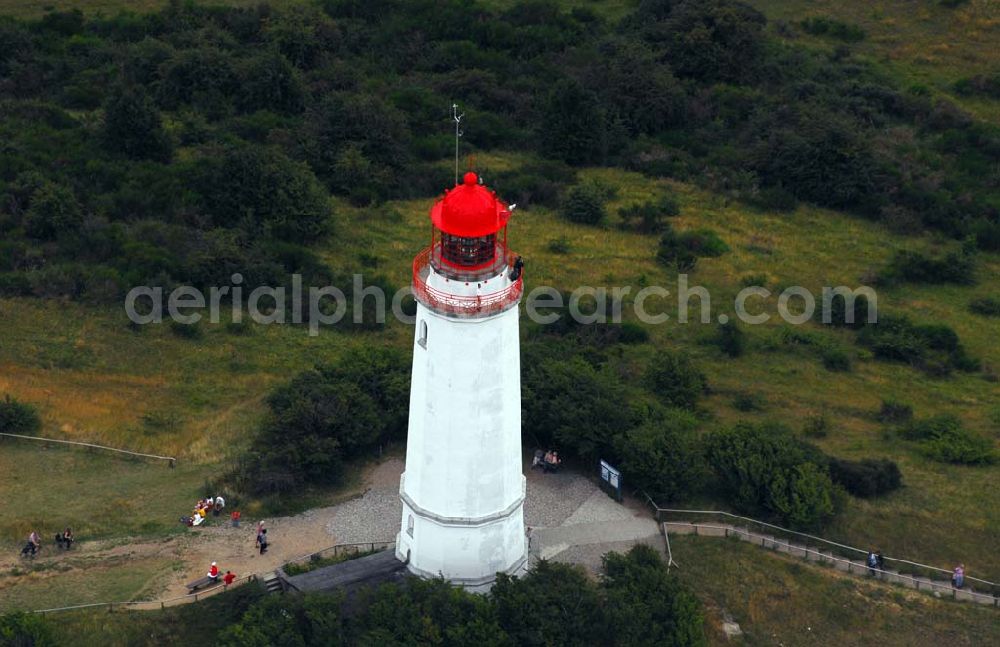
[431,171,510,238]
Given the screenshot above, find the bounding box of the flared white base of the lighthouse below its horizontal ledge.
[396,480,528,590]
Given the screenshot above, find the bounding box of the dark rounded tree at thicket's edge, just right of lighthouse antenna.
[538,79,607,166]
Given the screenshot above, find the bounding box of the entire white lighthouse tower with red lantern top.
[396,172,527,588]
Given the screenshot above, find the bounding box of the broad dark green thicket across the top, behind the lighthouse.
[0,0,1000,301]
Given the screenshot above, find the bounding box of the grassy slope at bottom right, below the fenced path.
[671,536,1000,646]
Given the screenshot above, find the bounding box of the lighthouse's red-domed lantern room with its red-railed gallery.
[413,172,522,315]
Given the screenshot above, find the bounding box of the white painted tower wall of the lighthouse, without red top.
[397,264,527,586]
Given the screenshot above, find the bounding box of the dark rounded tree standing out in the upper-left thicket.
[103,88,171,162]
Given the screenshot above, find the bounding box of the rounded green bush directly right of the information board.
[614,409,704,503]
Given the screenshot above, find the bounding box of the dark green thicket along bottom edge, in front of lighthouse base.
[221,546,705,646]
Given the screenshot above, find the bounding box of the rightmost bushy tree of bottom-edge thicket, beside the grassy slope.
[601,544,707,647]
